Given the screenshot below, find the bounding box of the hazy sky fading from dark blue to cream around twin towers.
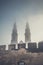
[0,0,43,44]
